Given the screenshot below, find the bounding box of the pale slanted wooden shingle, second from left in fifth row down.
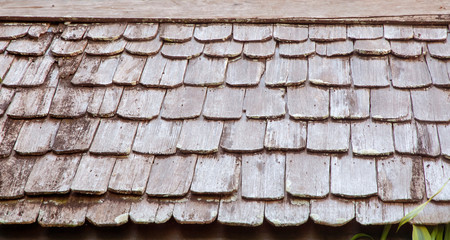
[14,119,60,155]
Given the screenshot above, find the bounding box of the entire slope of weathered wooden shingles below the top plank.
[0,23,450,226]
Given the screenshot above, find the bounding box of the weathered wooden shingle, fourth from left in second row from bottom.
[108,154,153,195]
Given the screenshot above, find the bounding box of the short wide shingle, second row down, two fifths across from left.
[161,40,204,59]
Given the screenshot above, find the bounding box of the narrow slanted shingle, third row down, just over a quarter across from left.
[113,53,147,85]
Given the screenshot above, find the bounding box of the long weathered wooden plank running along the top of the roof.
[0,0,450,22]
